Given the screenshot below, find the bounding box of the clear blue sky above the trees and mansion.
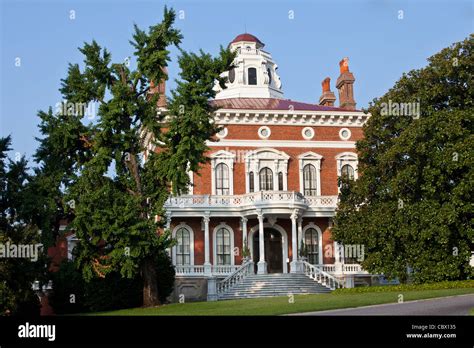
[0,0,474,158]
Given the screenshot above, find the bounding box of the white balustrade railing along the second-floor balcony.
[165,191,338,208]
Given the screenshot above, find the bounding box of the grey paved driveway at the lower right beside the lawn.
[293,294,474,315]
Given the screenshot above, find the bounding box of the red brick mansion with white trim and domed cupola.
[159,34,370,300]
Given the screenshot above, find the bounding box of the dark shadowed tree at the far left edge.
[0,137,44,315]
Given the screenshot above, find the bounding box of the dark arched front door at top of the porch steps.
[253,228,283,273]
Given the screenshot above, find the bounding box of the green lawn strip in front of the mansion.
[86,288,474,315]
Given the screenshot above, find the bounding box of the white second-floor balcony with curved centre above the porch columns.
[165,191,338,215]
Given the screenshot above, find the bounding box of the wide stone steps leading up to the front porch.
[218,273,331,300]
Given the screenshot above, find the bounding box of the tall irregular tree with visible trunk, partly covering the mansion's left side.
[38,4,234,306]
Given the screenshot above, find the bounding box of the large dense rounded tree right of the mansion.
[333,35,474,282]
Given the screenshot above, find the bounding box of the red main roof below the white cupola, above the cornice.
[212,98,358,111]
